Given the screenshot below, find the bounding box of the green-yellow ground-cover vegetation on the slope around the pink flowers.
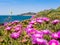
[0,7,60,45]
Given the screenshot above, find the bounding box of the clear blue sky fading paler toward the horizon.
[0,0,60,15]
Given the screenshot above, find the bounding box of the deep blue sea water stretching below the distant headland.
[0,15,32,23]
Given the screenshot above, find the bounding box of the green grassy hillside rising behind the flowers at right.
[35,7,60,19]
